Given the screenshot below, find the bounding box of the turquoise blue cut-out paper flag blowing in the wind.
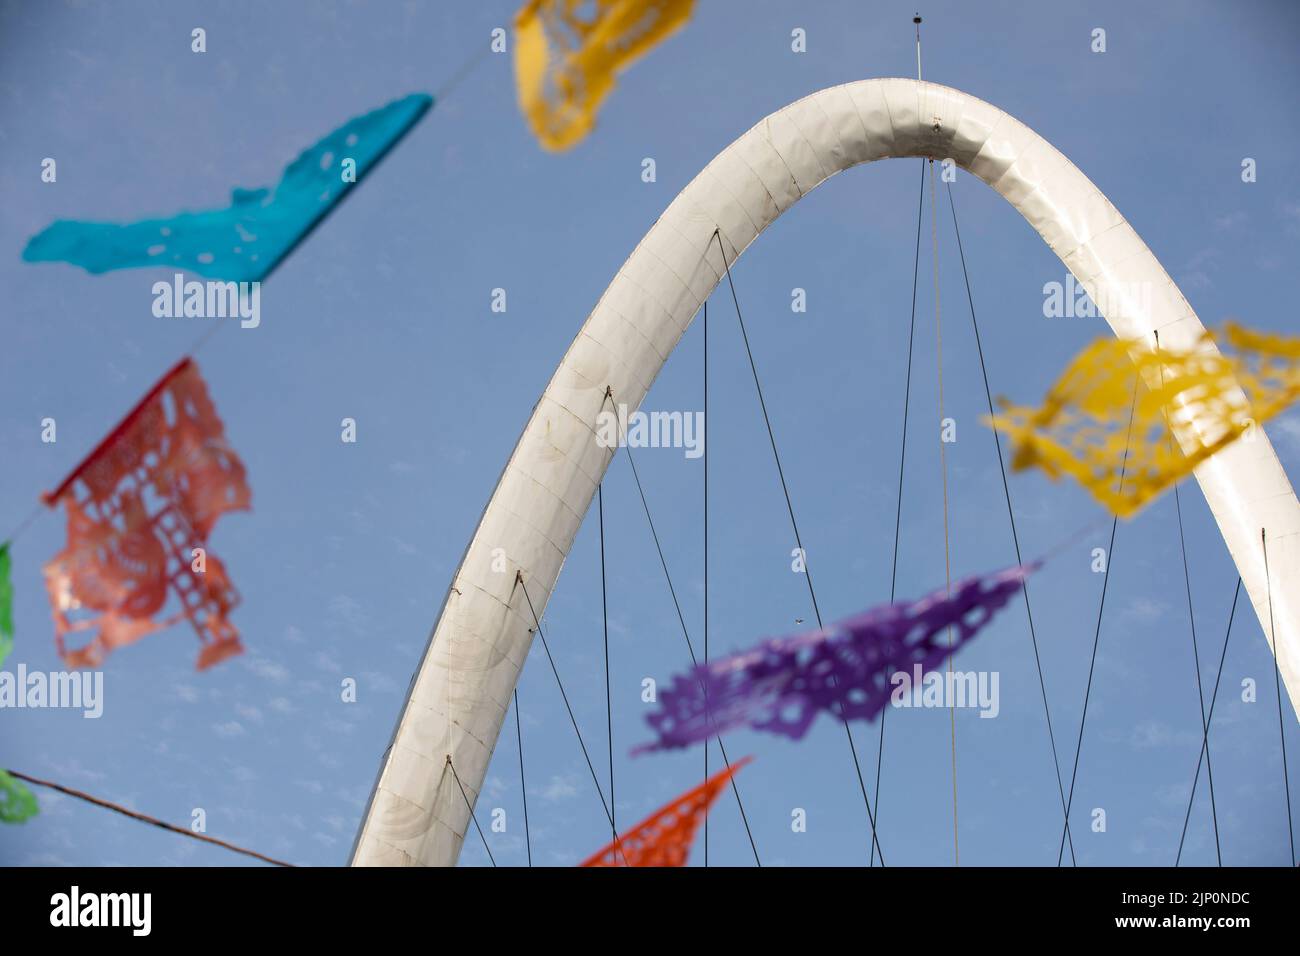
[22,94,433,282]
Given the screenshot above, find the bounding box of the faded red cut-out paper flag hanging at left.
[43,358,252,670]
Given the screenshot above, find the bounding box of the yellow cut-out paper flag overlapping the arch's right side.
[985,323,1300,518]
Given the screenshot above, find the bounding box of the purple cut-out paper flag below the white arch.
[633,563,1037,753]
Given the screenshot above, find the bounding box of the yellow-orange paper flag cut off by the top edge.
[515,0,694,151]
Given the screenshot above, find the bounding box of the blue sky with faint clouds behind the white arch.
[0,0,1300,865]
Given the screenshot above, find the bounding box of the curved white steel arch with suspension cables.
[352,79,1300,865]
